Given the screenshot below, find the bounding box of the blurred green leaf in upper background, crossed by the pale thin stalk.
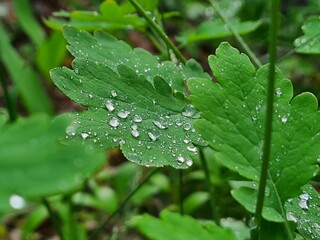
[177,19,261,46]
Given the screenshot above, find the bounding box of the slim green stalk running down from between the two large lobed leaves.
[199,147,220,225]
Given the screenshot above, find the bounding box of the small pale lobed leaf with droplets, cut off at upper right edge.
[294,16,320,54]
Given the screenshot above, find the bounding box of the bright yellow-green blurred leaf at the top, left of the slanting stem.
[46,0,146,31]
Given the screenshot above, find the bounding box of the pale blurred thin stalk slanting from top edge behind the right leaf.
[209,0,262,68]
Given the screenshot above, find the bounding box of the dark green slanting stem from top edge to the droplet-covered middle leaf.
[129,0,187,64]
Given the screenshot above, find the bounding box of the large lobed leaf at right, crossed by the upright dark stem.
[188,43,320,221]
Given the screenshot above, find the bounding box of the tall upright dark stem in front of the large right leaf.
[255,0,280,239]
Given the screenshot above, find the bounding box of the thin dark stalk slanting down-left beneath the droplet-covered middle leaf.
[89,168,160,240]
